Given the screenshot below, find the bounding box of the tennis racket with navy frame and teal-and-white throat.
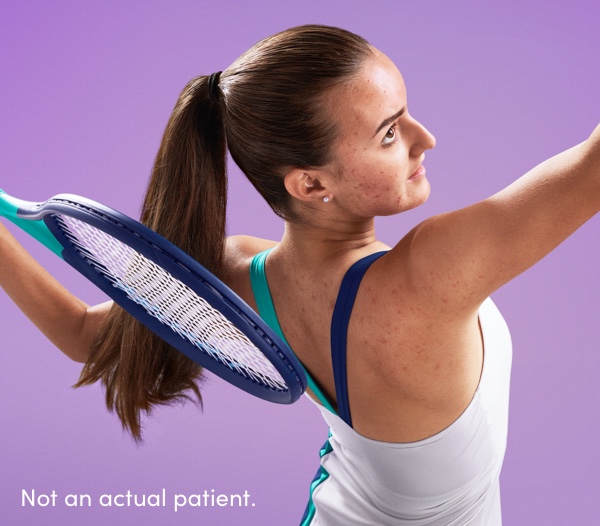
[0,190,306,404]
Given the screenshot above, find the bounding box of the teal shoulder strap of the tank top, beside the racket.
[250,249,337,415]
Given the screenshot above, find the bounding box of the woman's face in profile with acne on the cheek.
[326,49,435,218]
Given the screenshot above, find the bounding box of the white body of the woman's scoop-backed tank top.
[309,299,512,526]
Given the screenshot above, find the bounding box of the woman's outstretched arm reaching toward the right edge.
[397,126,600,313]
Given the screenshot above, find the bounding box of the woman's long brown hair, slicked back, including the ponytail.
[76,25,372,440]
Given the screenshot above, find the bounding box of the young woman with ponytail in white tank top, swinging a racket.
[0,26,600,526]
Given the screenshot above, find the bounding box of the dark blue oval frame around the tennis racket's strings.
[18,194,307,404]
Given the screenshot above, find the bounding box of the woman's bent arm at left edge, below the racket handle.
[0,223,112,362]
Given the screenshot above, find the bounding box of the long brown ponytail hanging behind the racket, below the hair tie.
[75,77,227,441]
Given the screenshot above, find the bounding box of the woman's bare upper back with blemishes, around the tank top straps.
[226,236,483,442]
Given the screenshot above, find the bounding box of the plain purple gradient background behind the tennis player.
[0,0,600,526]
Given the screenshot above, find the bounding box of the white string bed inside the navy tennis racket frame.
[54,214,288,391]
